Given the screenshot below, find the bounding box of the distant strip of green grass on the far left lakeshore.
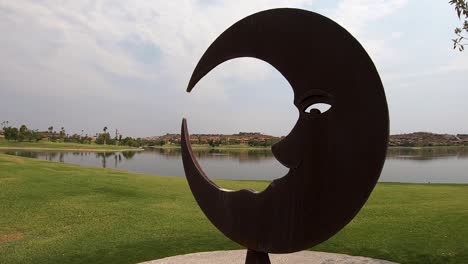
[0,138,140,150]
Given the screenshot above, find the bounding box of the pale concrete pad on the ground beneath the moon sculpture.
[142,250,395,264]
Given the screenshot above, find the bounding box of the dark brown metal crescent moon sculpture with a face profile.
[182,8,389,253]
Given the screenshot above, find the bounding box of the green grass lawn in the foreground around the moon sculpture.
[0,154,468,263]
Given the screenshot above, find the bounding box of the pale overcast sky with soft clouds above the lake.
[0,0,468,136]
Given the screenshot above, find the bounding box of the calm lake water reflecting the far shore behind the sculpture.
[1,147,468,183]
